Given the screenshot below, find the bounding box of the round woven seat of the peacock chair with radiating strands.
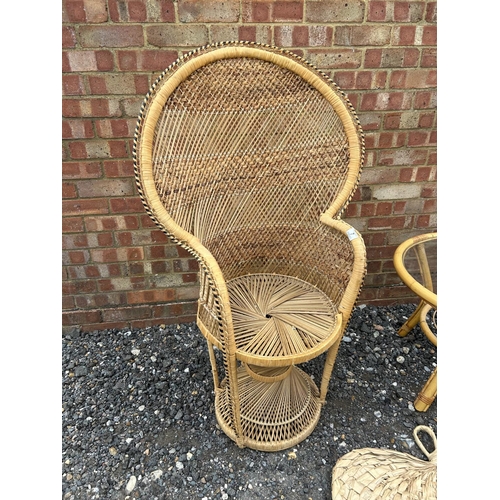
[227,274,340,366]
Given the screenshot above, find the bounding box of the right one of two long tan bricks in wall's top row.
[305,0,366,23]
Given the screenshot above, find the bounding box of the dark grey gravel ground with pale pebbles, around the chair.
[62,304,437,500]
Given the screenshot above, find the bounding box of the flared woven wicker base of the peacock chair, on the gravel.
[215,366,321,451]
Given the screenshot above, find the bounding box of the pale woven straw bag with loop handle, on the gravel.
[332,425,437,500]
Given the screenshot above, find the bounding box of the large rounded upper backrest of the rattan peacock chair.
[135,42,364,254]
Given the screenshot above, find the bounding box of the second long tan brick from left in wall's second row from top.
[145,24,209,47]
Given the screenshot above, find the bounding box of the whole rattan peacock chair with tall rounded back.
[134,42,366,451]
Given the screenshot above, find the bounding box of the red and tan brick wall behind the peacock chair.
[62,0,437,330]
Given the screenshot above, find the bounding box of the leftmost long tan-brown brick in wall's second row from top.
[78,25,144,47]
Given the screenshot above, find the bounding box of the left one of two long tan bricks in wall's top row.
[178,0,240,23]
